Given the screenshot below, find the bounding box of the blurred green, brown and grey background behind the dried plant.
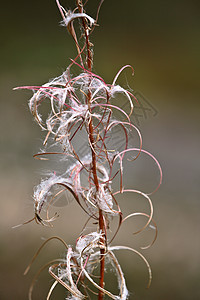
[0,0,200,300]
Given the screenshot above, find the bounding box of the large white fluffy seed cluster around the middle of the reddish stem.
[24,66,145,224]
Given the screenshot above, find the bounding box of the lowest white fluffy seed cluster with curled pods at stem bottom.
[47,232,130,300]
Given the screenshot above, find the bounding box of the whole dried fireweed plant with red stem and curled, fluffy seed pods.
[16,0,162,300]
